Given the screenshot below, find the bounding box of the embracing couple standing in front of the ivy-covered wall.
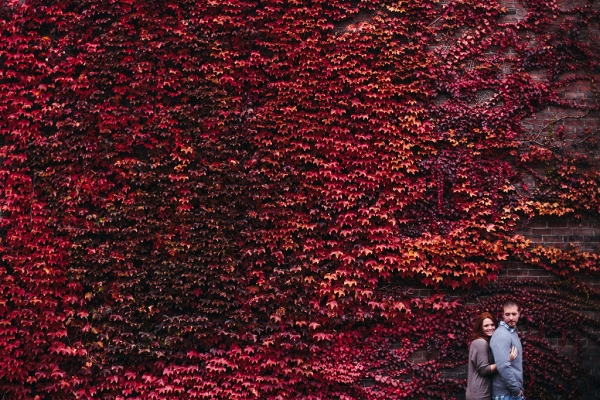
[467,300,525,400]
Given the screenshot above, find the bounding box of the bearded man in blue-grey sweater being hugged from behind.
[490,300,523,400]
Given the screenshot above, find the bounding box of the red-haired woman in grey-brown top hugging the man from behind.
[467,312,517,400]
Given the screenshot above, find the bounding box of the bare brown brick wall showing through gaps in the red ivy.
[363,0,600,400]
